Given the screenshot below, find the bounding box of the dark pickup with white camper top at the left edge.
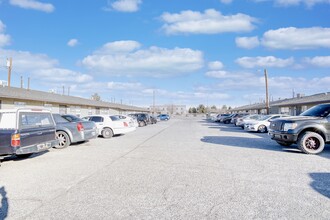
[0,108,58,162]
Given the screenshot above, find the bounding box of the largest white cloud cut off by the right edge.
[261,27,330,50]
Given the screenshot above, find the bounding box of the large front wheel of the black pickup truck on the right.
[298,132,325,154]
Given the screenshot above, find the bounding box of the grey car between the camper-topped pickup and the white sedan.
[53,114,97,149]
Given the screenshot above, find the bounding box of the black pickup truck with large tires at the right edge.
[269,103,330,154]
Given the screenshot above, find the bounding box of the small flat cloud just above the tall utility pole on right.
[236,56,294,68]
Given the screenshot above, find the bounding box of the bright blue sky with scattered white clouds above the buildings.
[0,0,330,107]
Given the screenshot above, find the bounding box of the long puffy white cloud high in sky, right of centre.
[161,9,257,34]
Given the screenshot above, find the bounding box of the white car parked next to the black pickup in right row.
[244,114,289,133]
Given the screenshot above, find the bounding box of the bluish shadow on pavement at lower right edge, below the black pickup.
[309,173,330,199]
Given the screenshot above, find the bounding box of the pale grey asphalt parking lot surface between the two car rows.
[0,117,330,219]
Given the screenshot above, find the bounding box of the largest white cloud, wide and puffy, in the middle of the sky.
[81,41,204,77]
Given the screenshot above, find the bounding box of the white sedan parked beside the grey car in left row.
[83,115,136,138]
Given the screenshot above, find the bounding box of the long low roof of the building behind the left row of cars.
[0,87,148,112]
